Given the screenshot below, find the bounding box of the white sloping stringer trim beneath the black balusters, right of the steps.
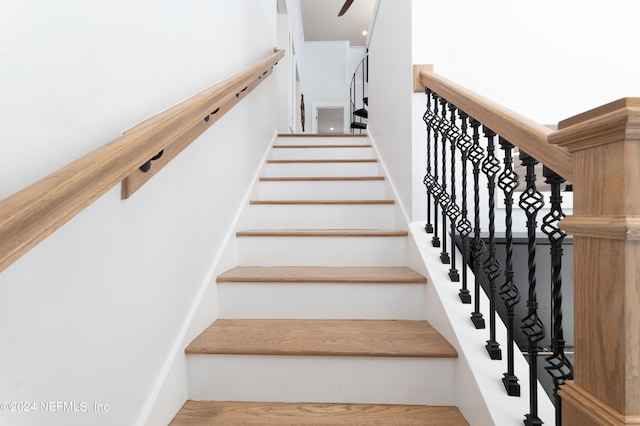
[368,129,555,426]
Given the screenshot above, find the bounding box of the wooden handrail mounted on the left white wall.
[0,50,284,271]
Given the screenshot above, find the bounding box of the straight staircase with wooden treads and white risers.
[171,135,468,425]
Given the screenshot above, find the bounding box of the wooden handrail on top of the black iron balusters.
[414,68,573,181]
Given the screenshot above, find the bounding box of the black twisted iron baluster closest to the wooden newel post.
[542,167,573,426]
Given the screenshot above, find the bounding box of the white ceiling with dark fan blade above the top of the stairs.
[300,0,376,46]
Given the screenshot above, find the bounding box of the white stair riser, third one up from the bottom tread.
[237,236,406,266]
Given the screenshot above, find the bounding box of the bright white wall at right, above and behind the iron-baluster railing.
[413,0,640,224]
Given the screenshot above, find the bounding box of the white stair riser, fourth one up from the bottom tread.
[249,204,394,229]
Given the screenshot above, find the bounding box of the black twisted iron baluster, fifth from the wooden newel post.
[469,118,487,329]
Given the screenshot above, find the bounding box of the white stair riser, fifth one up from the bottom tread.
[258,180,384,200]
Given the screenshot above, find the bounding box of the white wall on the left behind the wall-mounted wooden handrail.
[0,0,277,425]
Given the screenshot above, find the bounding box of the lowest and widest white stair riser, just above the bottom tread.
[188,355,456,405]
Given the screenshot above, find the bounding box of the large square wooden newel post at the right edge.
[549,98,640,426]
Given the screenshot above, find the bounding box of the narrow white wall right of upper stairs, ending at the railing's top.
[368,0,415,220]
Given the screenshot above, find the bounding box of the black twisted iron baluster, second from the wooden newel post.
[519,151,544,426]
